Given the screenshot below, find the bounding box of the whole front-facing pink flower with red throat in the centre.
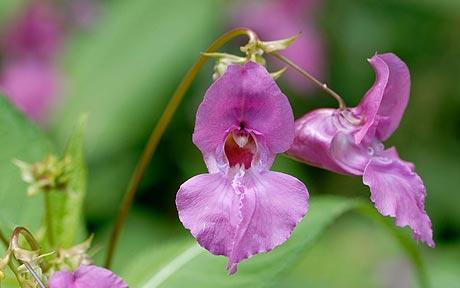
[176,62,308,274]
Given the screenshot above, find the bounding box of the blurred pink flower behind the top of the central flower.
[234,0,325,90]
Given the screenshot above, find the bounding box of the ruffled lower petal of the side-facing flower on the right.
[363,157,435,247]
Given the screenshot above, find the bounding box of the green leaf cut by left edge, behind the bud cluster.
[0,95,53,234]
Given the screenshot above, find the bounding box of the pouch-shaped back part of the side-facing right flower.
[286,109,349,174]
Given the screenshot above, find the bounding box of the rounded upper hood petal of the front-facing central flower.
[193,62,294,157]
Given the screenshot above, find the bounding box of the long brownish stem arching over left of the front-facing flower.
[105,28,257,268]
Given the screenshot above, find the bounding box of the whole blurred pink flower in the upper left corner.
[0,1,63,122]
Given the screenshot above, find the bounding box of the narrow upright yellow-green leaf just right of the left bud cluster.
[49,116,87,248]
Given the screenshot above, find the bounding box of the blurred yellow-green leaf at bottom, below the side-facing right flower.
[279,213,416,288]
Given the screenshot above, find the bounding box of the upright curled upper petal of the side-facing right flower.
[355,53,410,144]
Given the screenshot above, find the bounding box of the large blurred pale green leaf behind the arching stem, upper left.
[55,0,219,159]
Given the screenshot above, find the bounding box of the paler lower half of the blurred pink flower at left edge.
[0,59,58,122]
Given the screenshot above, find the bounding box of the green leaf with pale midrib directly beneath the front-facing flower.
[121,197,428,288]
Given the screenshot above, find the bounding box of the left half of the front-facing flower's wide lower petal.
[176,173,241,256]
